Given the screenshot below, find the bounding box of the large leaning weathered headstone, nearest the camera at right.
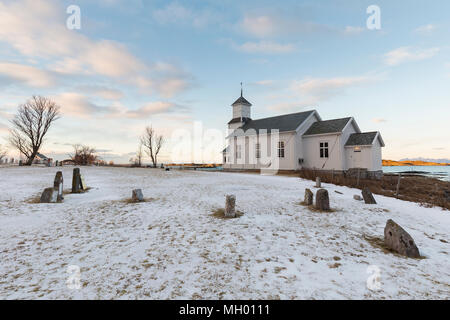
[384,219,420,258]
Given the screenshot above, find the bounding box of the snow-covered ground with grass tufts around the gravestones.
[0,167,450,299]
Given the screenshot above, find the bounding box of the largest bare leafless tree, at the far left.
[9,96,60,166]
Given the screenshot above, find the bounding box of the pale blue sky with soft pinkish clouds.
[0,0,450,163]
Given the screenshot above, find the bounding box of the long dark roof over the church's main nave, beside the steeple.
[232,110,316,133]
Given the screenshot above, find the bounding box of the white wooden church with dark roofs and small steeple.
[223,90,384,176]
